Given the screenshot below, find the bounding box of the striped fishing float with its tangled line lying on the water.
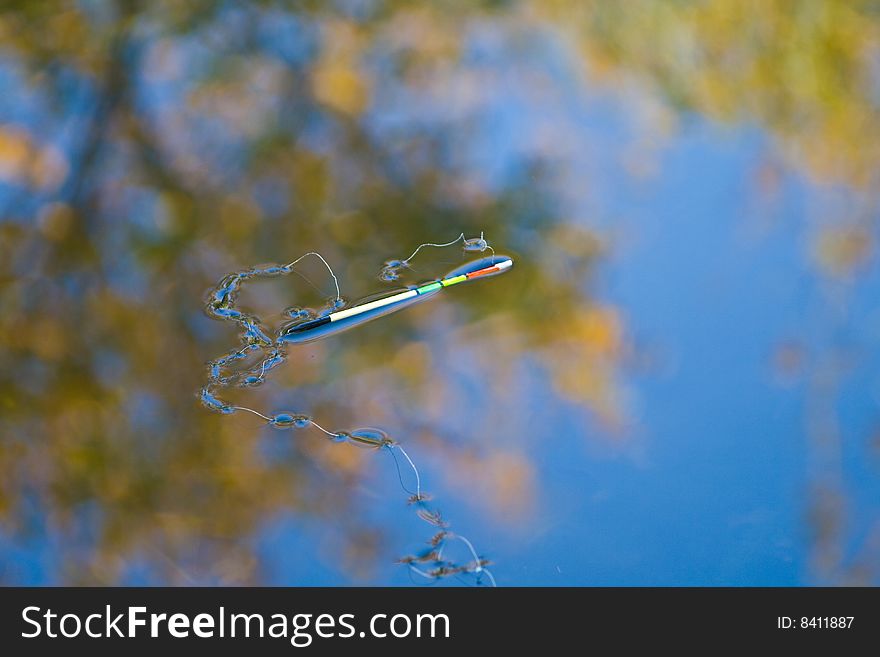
[199,233,513,586]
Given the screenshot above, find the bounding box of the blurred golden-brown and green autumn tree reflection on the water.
[0,0,880,583]
